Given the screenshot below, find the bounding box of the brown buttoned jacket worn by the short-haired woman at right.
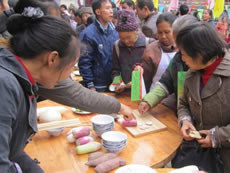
[178,51,230,173]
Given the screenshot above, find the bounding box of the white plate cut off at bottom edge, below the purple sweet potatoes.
[115,164,156,173]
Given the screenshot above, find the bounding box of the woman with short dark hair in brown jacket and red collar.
[174,22,230,173]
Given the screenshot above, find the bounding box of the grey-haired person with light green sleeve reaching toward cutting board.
[138,15,198,114]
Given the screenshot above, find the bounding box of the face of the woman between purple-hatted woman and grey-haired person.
[157,21,174,46]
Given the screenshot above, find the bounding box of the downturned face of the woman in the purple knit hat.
[119,31,138,47]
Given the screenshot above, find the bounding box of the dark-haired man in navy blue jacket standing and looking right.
[78,0,119,91]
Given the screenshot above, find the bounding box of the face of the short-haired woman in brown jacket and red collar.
[179,47,209,70]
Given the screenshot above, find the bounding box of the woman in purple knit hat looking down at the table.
[112,10,152,92]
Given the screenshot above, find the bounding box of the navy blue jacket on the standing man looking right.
[78,20,119,89]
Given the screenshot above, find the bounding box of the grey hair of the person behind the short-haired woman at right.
[172,14,198,33]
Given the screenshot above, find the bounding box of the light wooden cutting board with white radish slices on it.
[122,110,167,136]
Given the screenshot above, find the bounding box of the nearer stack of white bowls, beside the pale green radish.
[101,131,127,153]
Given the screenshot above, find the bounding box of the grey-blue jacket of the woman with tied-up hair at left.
[0,48,43,173]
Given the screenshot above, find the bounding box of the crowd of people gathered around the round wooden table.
[0,0,230,173]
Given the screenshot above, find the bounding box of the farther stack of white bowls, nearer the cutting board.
[91,115,114,136]
